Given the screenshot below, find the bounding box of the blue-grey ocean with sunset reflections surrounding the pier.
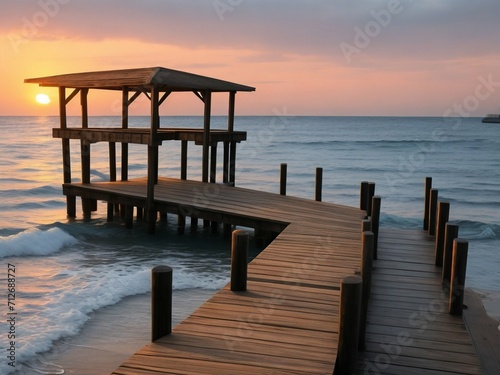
[0,116,500,375]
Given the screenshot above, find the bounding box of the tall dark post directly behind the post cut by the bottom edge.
[358,232,375,349]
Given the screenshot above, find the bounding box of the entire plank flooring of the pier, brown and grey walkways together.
[64,179,483,375]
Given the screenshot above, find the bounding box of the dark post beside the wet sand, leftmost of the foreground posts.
[151,266,172,342]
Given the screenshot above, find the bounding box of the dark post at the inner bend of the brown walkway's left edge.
[231,229,249,292]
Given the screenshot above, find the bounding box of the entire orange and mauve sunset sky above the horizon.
[0,0,500,117]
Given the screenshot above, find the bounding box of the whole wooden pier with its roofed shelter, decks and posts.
[26,68,483,375]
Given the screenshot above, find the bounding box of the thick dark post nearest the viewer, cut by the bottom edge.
[334,276,362,375]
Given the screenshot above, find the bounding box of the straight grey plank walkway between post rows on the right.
[357,229,483,375]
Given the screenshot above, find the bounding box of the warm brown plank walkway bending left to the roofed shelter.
[64,179,364,375]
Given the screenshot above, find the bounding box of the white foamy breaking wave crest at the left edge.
[0,228,77,258]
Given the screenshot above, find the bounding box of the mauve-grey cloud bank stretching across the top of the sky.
[0,0,500,65]
